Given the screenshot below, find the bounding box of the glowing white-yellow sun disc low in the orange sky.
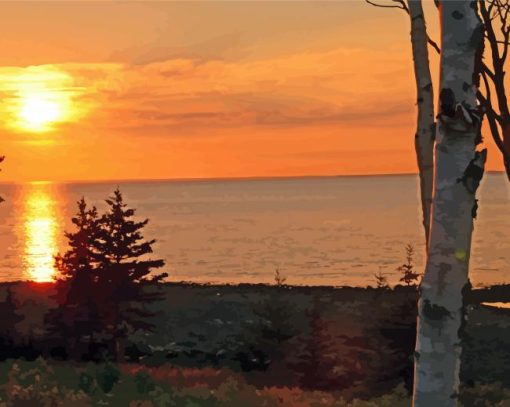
[17,91,65,132]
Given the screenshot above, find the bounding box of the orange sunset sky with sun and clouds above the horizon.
[0,0,502,182]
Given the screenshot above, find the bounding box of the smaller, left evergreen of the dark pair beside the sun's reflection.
[47,198,101,358]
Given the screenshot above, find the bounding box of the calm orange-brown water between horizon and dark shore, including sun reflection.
[0,174,510,286]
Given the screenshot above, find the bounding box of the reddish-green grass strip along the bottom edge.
[0,359,510,407]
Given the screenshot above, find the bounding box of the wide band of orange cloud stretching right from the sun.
[0,48,413,136]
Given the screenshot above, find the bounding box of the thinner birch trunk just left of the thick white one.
[408,0,436,243]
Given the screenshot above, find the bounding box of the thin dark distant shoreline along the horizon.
[0,171,505,185]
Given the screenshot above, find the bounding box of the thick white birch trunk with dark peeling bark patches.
[413,0,487,407]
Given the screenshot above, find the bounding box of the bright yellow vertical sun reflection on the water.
[23,183,58,282]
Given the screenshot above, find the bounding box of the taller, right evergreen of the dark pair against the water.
[94,188,167,361]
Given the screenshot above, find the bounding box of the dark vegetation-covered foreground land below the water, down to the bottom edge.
[0,283,510,406]
